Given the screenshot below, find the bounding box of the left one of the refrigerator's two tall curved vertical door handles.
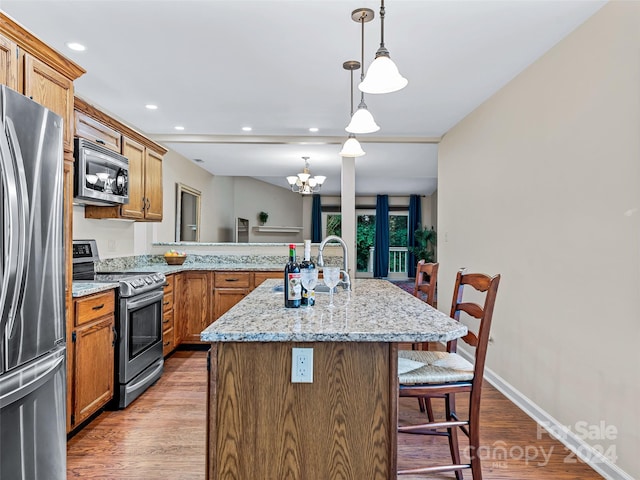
[0,118,20,336]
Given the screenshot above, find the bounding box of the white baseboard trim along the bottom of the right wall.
[458,348,634,480]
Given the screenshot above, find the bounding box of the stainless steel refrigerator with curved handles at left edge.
[0,86,66,480]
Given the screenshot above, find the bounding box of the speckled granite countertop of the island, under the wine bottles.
[200,279,467,342]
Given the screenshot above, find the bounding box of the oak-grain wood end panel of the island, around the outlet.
[209,342,396,480]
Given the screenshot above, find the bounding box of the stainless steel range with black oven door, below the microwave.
[73,240,166,408]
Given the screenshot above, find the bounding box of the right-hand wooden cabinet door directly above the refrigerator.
[24,54,73,152]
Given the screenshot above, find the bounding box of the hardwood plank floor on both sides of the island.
[67,351,602,480]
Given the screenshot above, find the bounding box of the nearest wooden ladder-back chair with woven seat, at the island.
[398,270,500,480]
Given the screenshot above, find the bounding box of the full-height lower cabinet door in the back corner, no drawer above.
[179,272,213,343]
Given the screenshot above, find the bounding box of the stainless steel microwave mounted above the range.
[73,138,129,205]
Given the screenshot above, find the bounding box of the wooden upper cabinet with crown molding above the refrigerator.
[0,12,85,154]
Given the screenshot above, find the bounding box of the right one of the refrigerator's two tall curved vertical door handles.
[3,116,31,340]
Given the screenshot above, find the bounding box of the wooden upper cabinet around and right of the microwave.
[75,98,167,222]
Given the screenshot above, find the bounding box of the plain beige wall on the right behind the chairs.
[438,2,640,478]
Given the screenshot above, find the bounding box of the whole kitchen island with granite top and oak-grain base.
[200,280,467,480]
